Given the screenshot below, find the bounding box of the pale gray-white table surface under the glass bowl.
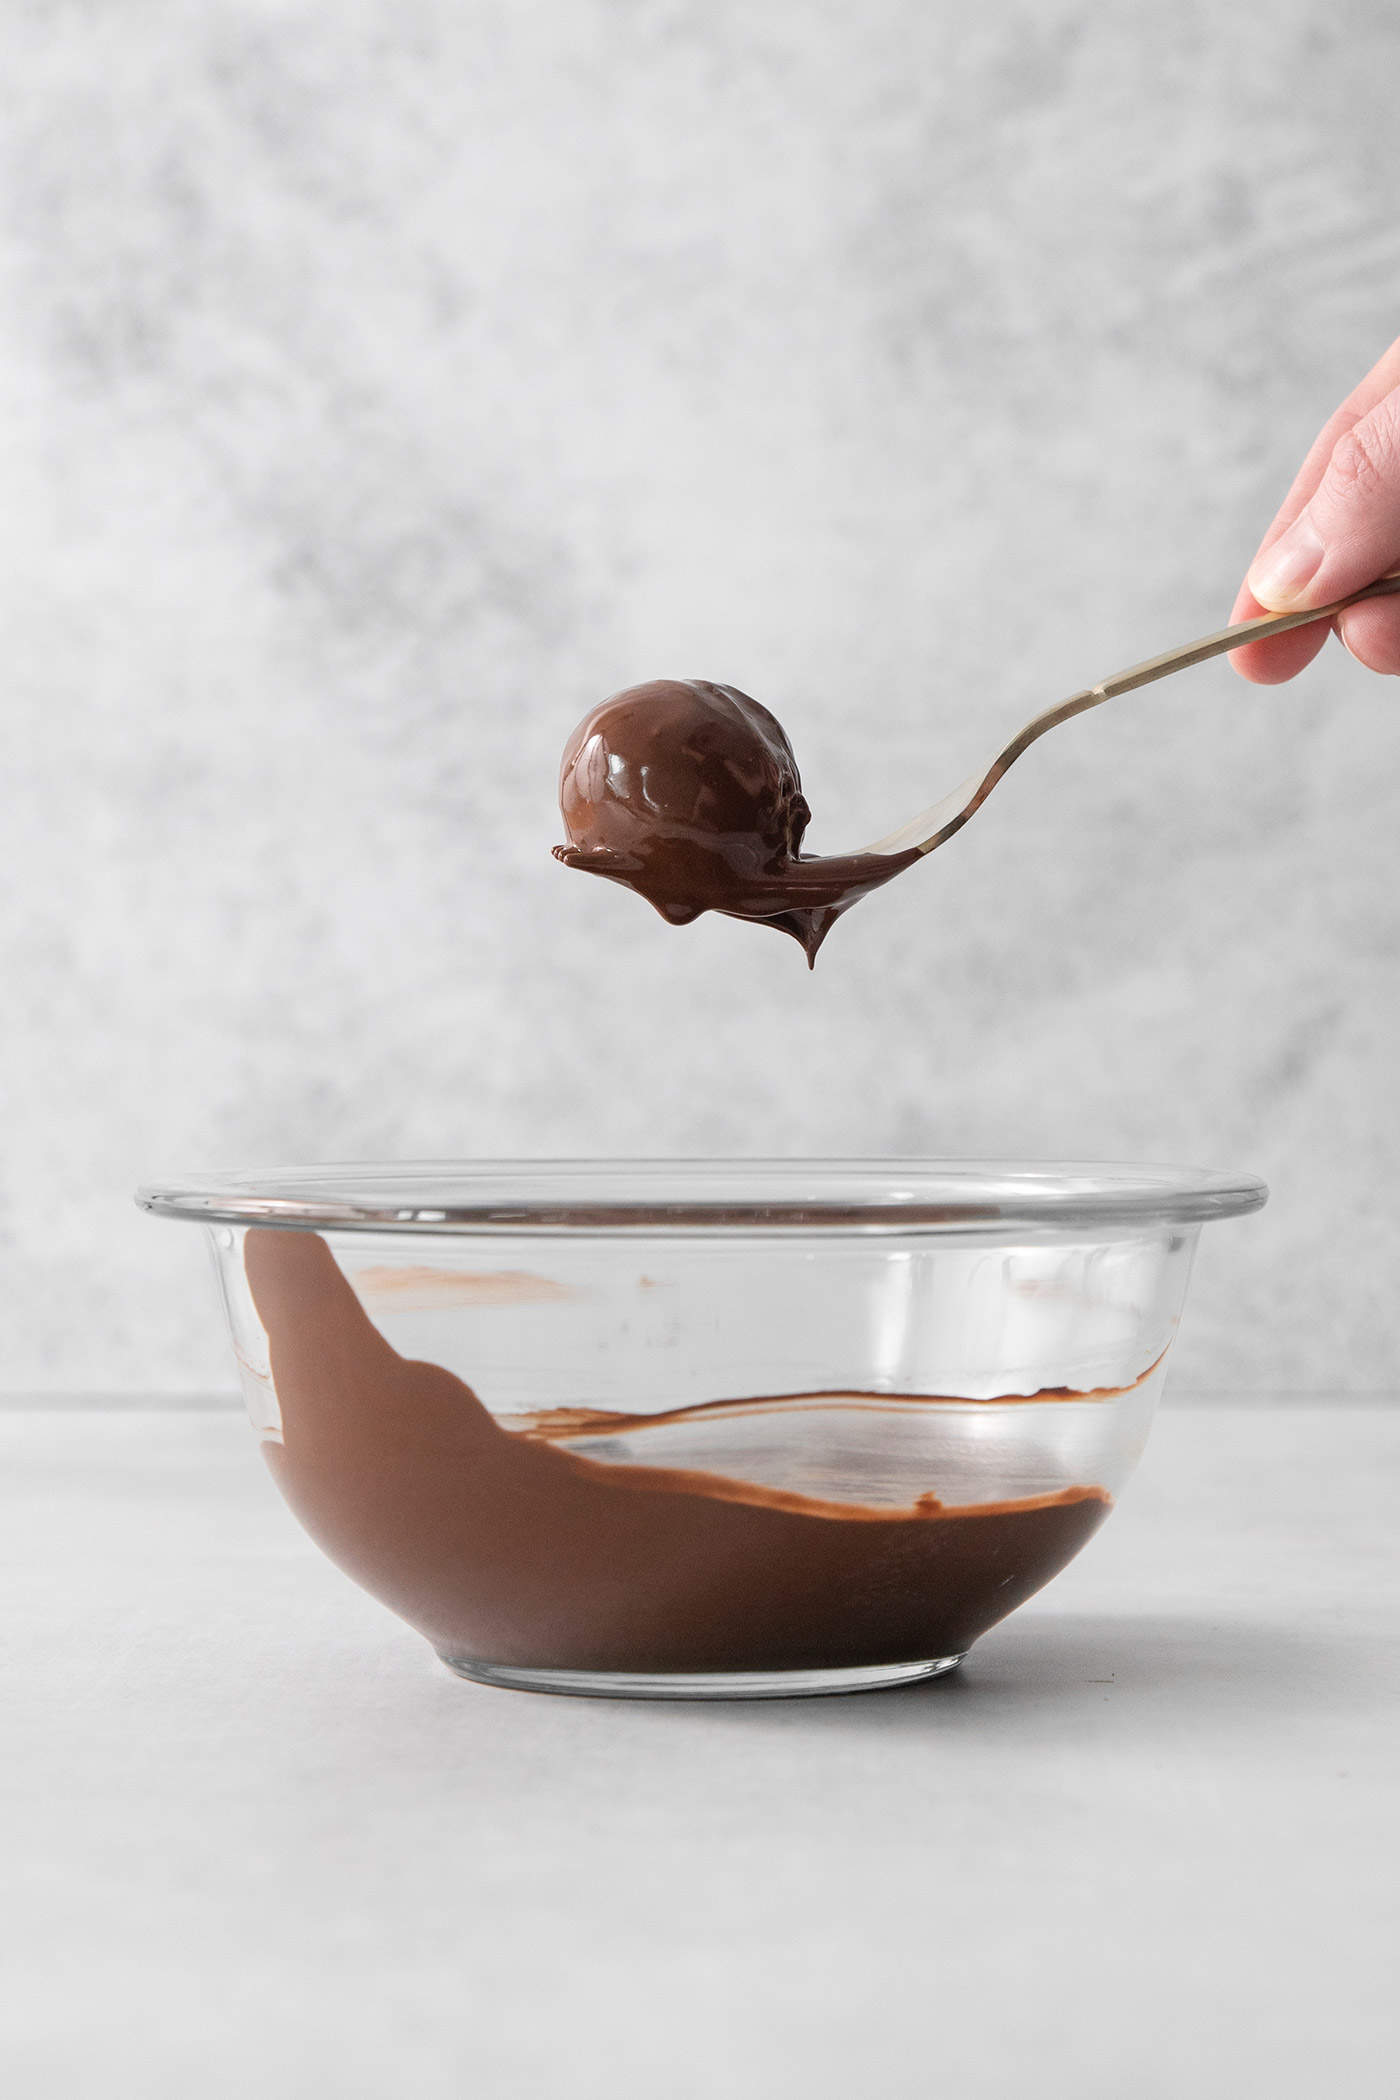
[0,1403,1400,2100]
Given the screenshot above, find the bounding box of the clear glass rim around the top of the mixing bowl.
[136,1157,1268,1239]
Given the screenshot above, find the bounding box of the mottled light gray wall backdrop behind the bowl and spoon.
[0,0,1400,1392]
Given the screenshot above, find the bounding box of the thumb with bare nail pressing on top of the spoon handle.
[1249,386,1400,613]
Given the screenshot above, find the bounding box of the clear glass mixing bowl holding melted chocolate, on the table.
[139,1161,1266,1697]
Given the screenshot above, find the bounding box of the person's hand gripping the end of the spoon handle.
[1230,340,1400,685]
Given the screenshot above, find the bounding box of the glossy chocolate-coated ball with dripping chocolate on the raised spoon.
[554,678,919,964]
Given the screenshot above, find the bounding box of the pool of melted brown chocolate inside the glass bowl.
[243,1226,1110,1674]
